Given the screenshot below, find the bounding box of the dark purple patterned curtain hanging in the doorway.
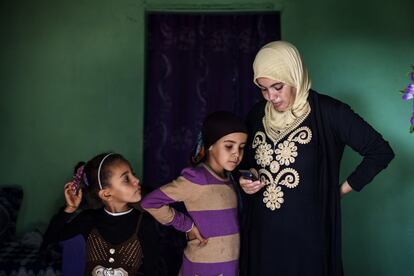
[143,12,280,188]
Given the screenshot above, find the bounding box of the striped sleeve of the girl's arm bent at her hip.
[141,176,193,232]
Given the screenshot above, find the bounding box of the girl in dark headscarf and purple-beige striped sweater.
[141,111,247,276]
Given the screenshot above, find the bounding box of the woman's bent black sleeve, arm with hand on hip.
[333,104,394,191]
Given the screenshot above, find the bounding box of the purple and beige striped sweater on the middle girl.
[141,164,240,276]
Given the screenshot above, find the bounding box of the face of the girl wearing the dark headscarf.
[207,132,247,175]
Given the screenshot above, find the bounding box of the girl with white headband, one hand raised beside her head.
[45,153,159,275]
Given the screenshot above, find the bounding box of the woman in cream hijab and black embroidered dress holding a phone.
[239,41,394,276]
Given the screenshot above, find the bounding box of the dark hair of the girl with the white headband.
[75,153,130,207]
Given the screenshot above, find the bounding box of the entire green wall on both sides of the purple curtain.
[0,0,414,276]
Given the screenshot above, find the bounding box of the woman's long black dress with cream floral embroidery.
[240,91,393,276]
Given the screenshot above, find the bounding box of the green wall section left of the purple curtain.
[0,1,144,232]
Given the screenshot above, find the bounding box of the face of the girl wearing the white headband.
[102,162,141,206]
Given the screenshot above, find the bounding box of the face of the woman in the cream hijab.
[256,78,296,112]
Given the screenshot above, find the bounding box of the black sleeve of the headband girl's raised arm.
[42,207,92,247]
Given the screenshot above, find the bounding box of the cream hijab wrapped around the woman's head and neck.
[253,41,311,140]
